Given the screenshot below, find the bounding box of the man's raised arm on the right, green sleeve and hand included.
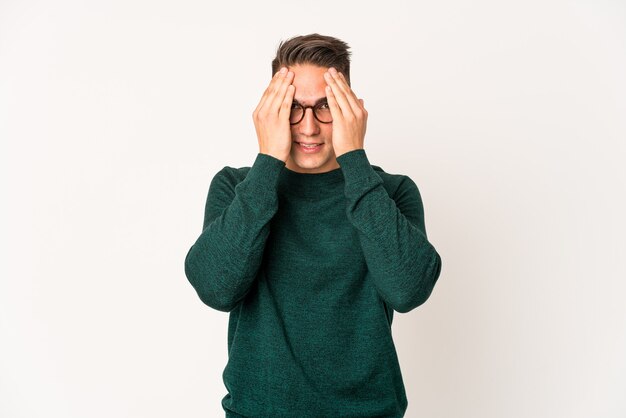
[324,68,441,313]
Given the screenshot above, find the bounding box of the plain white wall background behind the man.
[0,0,626,418]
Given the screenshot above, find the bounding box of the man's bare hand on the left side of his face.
[252,67,295,162]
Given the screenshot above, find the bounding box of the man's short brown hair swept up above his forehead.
[272,33,350,85]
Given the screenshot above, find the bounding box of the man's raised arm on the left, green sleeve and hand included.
[185,68,295,312]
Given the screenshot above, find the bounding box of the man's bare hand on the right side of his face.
[324,67,367,157]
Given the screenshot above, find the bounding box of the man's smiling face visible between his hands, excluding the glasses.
[285,64,339,173]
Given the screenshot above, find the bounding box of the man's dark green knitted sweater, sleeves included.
[185,149,441,418]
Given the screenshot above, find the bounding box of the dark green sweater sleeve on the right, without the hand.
[337,149,441,313]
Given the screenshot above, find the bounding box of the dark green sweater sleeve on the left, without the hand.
[185,153,285,312]
